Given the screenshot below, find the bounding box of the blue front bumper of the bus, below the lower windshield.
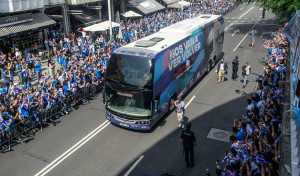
[105,113,151,131]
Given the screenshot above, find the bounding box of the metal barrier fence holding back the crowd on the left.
[0,84,102,152]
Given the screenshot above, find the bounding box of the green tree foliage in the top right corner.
[248,0,300,22]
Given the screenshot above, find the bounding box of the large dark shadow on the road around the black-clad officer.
[117,95,246,176]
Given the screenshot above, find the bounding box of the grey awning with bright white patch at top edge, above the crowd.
[128,0,165,15]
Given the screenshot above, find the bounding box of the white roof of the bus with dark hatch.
[116,15,221,53]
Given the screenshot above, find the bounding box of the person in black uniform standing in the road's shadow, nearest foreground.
[179,122,197,167]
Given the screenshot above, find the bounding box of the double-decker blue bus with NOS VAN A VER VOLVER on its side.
[103,15,224,131]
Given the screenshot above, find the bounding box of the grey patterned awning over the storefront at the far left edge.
[0,13,56,37]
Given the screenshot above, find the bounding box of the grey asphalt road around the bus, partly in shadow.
[0,4,277,176]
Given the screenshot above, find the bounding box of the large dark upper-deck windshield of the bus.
[106,54,153,89]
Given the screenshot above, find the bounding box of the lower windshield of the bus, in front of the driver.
[105,83,152,118]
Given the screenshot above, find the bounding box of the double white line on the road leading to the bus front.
[34,120,110,176]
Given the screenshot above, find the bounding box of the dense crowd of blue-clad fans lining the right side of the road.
[216,28,288,176]
